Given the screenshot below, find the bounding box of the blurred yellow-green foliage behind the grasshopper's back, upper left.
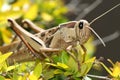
[0,0,67,45]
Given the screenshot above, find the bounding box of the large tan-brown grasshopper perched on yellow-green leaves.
[0,4,120,65]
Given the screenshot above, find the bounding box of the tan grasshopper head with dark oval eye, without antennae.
[75,20,91,44]
